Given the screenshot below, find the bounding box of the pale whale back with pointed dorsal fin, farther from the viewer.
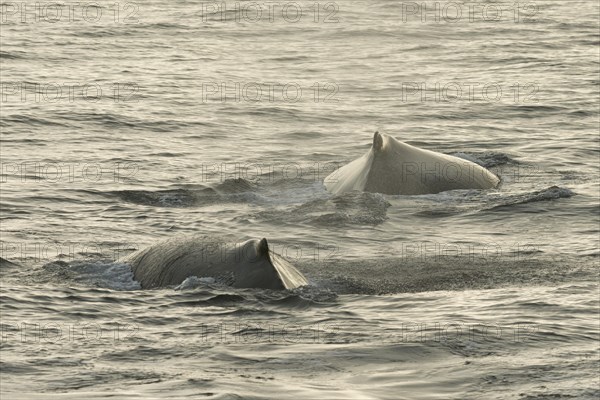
[324,132,500,195]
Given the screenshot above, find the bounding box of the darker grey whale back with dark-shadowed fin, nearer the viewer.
[119,236,308,290]
